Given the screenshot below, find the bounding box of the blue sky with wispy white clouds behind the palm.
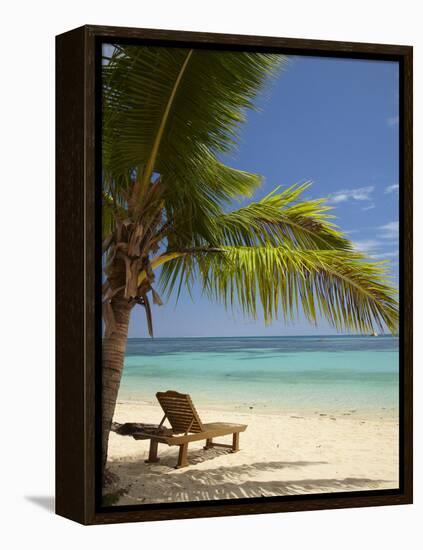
[129,57,399,337]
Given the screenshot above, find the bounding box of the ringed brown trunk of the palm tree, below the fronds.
[102,297,132,476]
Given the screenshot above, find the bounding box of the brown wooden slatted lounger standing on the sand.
[133,391,247,468]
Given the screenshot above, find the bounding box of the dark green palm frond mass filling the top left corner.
[103,45,286,215]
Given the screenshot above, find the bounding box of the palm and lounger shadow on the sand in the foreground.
[110,449,391,504]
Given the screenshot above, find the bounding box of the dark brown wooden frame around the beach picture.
[56,25,413,524]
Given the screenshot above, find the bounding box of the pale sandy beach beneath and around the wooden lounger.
[108,401,399,505]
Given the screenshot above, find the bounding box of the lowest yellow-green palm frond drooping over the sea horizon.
[161,245,398,333]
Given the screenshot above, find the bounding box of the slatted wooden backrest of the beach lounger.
[156,390,204,433]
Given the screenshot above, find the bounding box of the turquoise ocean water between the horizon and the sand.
[118,336,399,412]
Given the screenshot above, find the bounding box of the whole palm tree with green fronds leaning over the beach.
[102,45,398,476]
